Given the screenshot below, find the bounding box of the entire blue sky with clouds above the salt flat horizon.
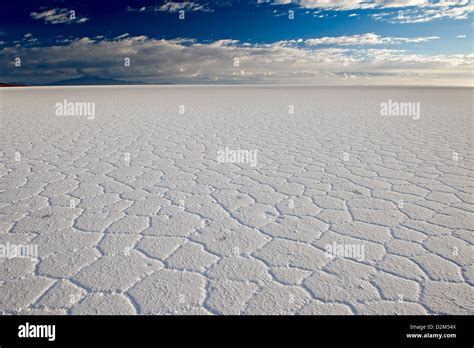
[0,0,474,86]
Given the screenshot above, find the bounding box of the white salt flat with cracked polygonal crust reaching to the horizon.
[0,86,474,314]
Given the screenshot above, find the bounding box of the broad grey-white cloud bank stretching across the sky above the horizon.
[0,34,474,85]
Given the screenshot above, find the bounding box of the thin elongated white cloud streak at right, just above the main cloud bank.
[305,33,439,46]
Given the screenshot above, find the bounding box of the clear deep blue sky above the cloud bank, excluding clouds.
[0,0,472,54]
